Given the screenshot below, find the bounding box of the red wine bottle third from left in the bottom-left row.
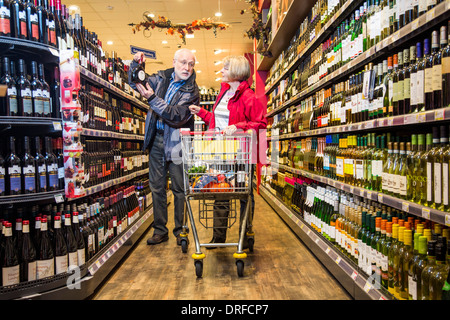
[36,218,55,279]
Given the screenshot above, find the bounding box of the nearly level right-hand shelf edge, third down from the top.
[267,107,450,141]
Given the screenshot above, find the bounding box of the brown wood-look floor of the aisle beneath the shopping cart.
[93,190,351,300]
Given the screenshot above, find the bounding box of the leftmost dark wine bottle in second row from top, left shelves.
[0,57,19,117]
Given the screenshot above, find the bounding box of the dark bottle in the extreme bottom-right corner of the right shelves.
[429,237,450,300]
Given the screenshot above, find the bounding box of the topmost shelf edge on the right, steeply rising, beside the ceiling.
[266,1,362,94]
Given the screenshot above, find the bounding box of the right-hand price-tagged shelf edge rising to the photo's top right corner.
[266,0,450,117]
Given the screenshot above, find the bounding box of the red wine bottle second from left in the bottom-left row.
[20,220,36,282]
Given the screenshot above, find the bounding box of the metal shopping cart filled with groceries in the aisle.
[180,131,254,277]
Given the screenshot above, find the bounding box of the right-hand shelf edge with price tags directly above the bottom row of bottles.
[271,163,450,227]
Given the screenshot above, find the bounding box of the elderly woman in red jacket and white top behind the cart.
[189,56,267,249]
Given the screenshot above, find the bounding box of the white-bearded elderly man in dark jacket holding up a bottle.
[130,49,199,245]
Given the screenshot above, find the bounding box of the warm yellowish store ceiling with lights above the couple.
[67,0,253,89]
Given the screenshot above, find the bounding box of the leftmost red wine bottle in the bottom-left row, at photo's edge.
[1,222,20,286]
